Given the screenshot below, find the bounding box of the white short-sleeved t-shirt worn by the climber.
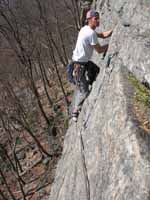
[72,25,98,62]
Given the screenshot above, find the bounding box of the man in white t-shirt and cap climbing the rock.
[72,10,112,121]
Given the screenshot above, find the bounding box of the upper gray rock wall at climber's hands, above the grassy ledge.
[97,0,150,86]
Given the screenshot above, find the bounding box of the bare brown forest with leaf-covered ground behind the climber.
[0,0,81,200]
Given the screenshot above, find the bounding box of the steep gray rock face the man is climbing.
[50,0,150,200]
